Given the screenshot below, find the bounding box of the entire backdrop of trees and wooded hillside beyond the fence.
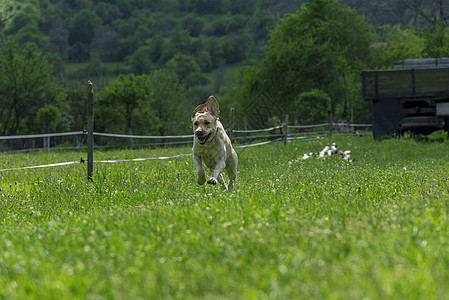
[0,0,449,135]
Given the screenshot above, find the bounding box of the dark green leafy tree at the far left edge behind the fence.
[0,40,60,135]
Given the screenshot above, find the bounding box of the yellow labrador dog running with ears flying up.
[192,96,237,190]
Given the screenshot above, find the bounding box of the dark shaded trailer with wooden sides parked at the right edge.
[361,58,449,138]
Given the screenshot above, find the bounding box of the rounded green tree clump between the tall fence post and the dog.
[95,70,189,135]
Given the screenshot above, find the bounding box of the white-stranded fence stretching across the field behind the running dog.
[0,115,371,153]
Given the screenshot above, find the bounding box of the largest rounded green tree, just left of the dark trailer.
[236,0,372,119]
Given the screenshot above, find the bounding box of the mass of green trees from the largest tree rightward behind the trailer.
[226,0,449,126]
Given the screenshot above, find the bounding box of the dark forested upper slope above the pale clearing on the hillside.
[2,0,299,75]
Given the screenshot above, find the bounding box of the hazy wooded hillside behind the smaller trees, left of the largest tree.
[0,0,299,134]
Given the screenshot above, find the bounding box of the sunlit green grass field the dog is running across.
[0,137,449,299]
